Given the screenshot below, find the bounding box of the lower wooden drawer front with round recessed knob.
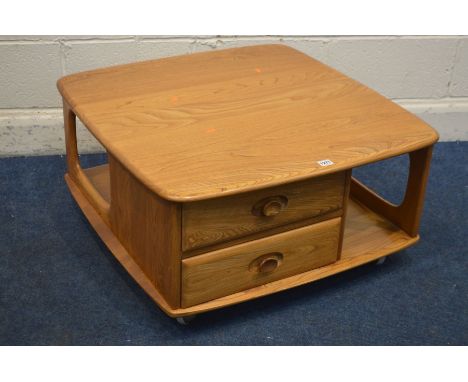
[182,218,341,307]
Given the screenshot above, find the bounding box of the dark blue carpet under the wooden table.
[0,142,468,345]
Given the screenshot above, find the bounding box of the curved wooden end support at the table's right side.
[351,146,432,237]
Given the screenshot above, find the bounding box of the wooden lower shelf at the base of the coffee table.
[65,165,419,317]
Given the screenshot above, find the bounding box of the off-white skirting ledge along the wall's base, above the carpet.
[0,97,468,157]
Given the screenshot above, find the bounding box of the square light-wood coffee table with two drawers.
[58,45,438,321]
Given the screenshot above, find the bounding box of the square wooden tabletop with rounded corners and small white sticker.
[58,45,438,203]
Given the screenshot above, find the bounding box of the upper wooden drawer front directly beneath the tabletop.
[182,172,345,251]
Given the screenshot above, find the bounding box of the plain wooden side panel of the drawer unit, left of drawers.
[109,155,181,308]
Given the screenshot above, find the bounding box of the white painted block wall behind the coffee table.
[0,36,468,156]
